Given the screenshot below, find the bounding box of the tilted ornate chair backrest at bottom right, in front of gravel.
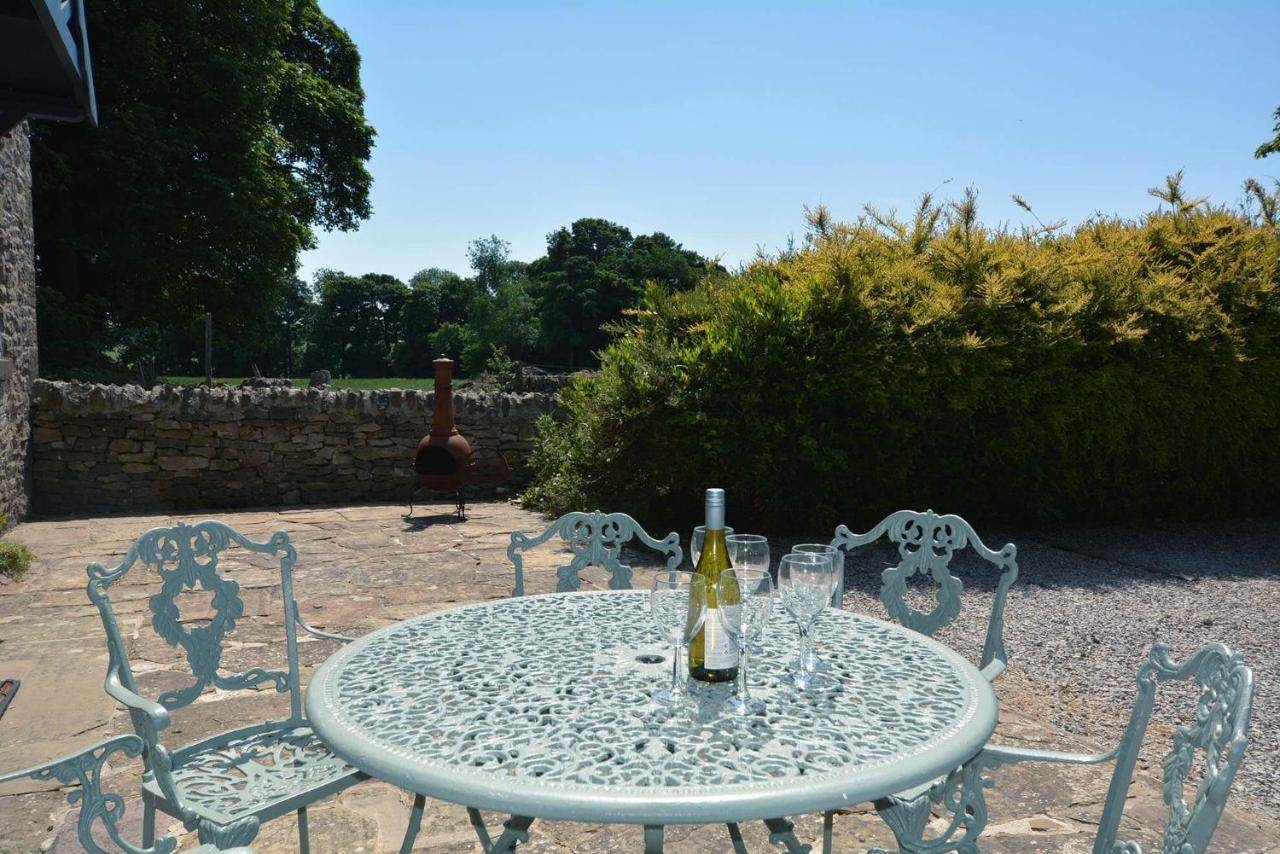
[1093,644,1253,854]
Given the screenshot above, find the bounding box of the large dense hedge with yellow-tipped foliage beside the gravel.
[526,177,1280,533]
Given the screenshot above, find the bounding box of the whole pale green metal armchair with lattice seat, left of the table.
[88,521,364,851]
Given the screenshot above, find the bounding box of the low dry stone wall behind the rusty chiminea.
[31,380,559,513]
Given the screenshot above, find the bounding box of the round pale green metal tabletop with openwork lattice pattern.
[306,592,997,825]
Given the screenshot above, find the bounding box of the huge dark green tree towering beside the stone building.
[32,0,374,373]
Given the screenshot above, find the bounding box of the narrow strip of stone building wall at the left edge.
[0,123,38,529]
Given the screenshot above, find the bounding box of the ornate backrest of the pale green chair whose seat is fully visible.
[88,520,302,798]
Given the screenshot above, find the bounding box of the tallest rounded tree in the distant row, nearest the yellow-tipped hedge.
[529,219,708,366]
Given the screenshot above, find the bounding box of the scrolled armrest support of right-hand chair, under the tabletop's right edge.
[876,753,993,854]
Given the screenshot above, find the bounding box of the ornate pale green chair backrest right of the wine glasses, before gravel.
[831,510,1018,680]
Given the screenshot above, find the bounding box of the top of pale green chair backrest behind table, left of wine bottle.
[507,510,685,597]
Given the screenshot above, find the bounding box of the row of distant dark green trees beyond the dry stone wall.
[46,219,718,379]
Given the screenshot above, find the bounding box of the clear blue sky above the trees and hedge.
[302,0,1280,285]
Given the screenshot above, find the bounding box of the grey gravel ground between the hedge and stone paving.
[808,516,1280,816]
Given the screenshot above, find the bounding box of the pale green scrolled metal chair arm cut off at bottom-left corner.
[0,735,253,854]
